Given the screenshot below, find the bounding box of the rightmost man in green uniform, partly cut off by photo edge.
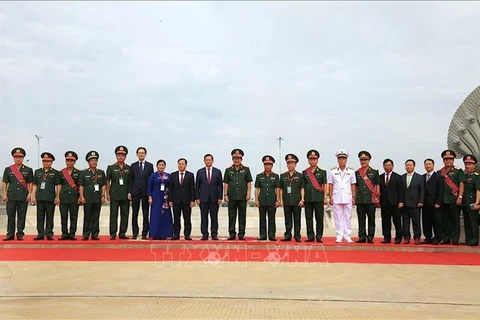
[462,154,480,246]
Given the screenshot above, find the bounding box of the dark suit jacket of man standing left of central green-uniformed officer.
[195,167,223,202]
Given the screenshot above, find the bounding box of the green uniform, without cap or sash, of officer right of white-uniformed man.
[355,167,380,242]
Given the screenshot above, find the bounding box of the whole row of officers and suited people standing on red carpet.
[2,146,480,246]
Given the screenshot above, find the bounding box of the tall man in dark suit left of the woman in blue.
[128,147,153,240]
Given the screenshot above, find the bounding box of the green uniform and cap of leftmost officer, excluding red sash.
[2,148,33,240]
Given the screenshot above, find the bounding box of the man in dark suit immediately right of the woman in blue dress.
[168,158,195,240]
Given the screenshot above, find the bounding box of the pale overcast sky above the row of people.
[0,1,480,174]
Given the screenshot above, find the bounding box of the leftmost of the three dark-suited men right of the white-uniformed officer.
[380,159,404,244]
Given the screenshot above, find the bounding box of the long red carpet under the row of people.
[0,236,480,265]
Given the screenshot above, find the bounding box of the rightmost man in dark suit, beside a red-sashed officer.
[422,158,444,245]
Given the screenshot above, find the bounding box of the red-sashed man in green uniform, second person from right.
[438,150,465,245]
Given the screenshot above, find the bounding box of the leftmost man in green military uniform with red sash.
[2,148,33,241]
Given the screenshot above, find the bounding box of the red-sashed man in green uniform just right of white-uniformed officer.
[355,151,380,243]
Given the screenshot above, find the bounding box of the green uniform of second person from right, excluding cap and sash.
[437,167,465,244]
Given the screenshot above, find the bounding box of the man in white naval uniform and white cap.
[328,149,356,243]
